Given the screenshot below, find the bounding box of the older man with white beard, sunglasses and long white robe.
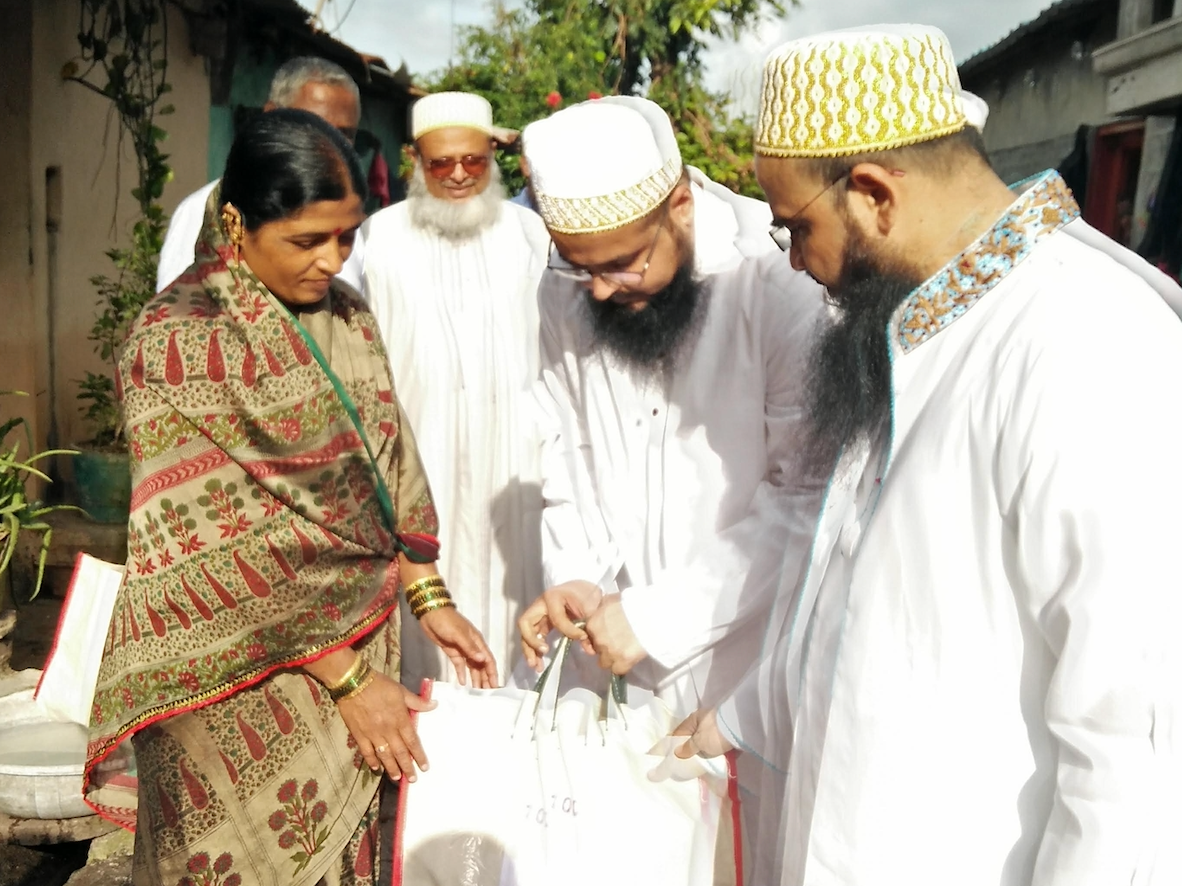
[364,93,550,690]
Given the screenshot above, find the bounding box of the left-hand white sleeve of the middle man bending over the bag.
[535,272,623,591]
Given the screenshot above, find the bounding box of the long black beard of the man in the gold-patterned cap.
[806,233,922,474]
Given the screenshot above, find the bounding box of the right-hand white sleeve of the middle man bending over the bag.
[622,262,825,669]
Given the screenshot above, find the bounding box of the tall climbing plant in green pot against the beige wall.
[61,0,174,523]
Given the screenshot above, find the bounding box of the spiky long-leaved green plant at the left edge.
[0,391,73,608]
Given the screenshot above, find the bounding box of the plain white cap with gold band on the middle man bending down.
[521,96,682,234]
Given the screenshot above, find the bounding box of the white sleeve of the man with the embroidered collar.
[1002,275,1182,886]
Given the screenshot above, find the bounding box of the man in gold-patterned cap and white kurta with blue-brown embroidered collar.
[680,26,1182,886]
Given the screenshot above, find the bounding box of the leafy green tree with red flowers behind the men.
[429,0,797,196]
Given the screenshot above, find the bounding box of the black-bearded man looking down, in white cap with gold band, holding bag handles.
[522,98,824,715]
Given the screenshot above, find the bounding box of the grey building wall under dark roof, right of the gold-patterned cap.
[962,5,1117,182]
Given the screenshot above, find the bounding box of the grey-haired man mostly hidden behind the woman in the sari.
[156,56,364,292]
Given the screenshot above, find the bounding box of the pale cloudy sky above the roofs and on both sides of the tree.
[300,0,1052,110]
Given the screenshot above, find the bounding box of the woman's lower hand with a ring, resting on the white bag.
[337,672,435,781]
